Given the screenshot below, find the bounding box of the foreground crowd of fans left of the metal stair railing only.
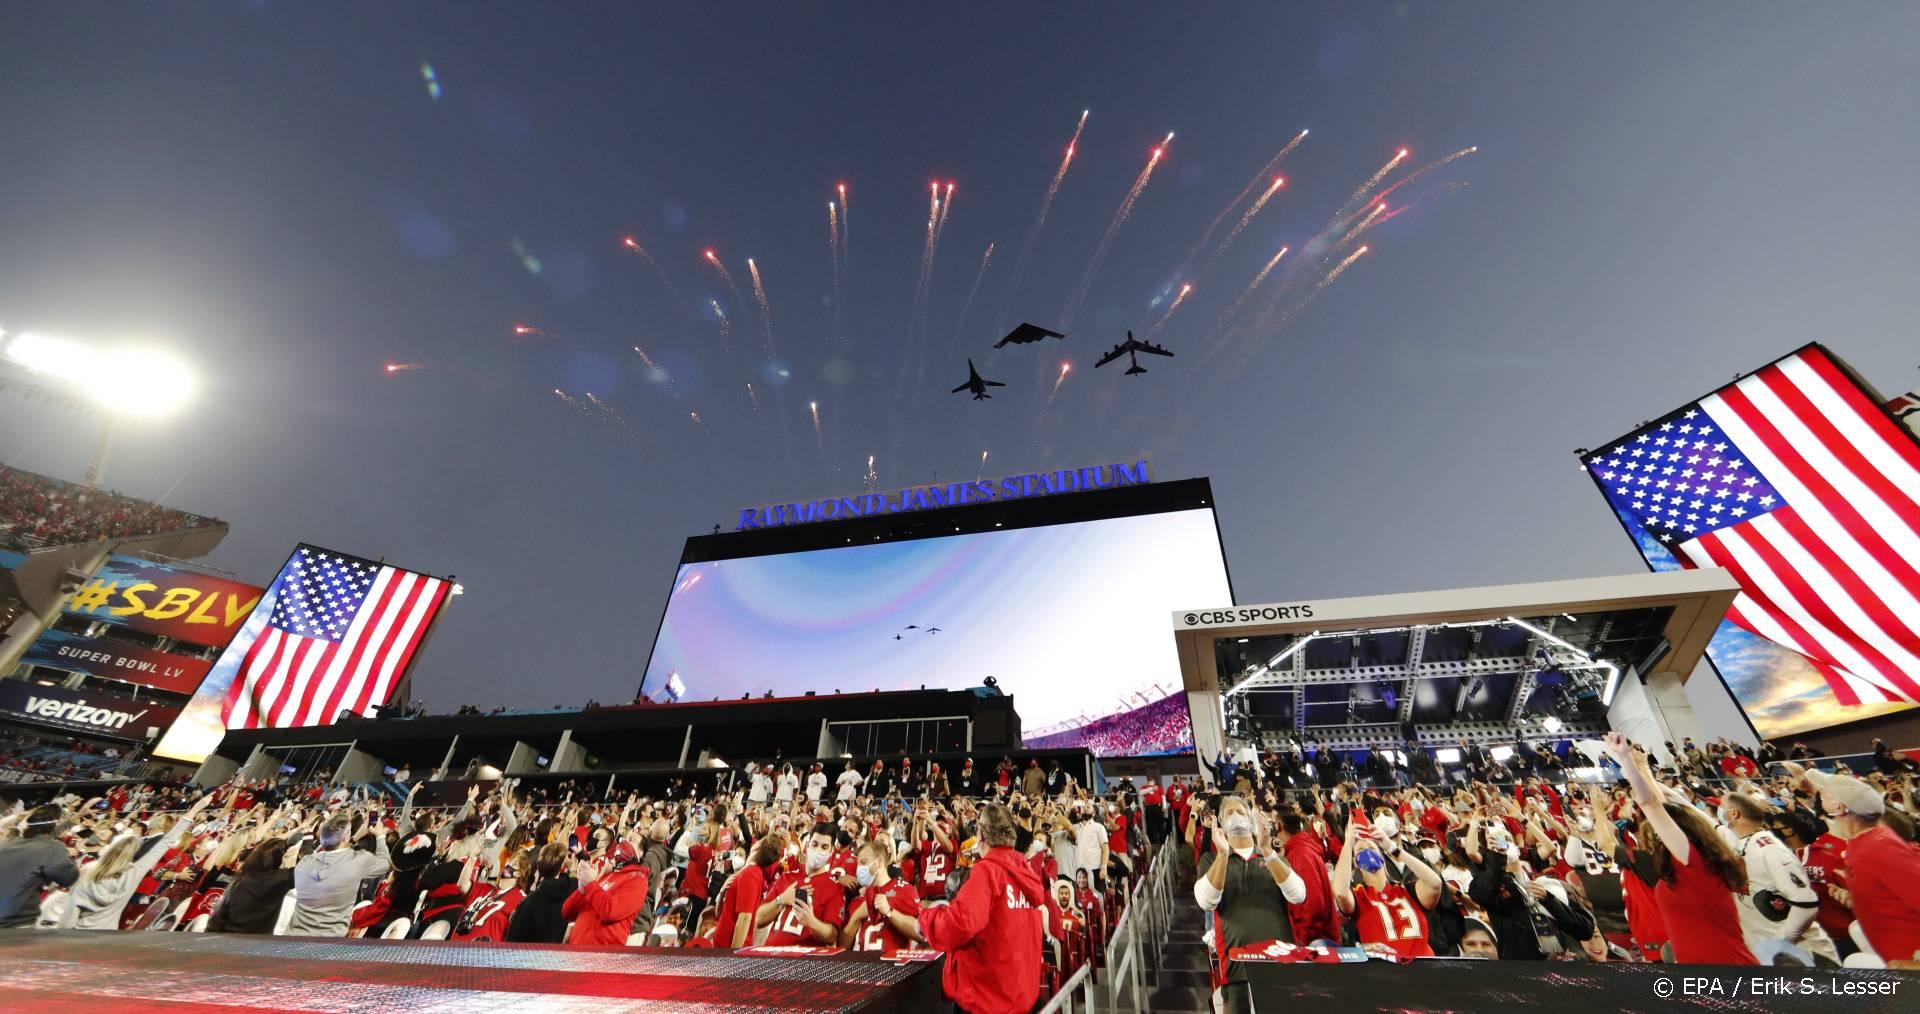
[0,757,1171,1012]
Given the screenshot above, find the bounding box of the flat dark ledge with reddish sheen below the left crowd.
[0,930,943,1014]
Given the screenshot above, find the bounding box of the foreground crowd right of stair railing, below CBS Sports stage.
[1175,734,1920,995]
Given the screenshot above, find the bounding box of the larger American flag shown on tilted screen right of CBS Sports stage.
[1586,346,1920,705]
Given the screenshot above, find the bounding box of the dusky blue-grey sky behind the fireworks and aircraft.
[0,0,1920,711]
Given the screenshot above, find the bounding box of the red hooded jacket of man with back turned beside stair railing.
[920,845,1046,1014]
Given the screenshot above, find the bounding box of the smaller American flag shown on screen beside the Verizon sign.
[221,545,449,728]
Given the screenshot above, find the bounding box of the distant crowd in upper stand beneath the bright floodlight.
[0,465,219,551]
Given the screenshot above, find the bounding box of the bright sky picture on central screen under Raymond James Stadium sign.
[641,509,1231,757]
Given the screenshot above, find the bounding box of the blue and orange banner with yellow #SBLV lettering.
[67,557,263,647]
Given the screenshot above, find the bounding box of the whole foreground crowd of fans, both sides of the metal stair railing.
[0,734,1920,1010]
